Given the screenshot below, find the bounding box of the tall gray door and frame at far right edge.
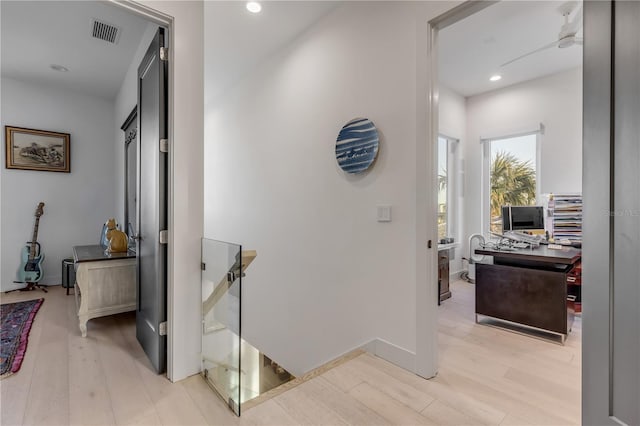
[582,1,640,425]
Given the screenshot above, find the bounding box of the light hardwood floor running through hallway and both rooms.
[0,282,580,425]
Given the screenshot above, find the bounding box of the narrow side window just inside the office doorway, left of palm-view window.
[438,135,458,240]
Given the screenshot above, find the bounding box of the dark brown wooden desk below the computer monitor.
[475,246,581,342]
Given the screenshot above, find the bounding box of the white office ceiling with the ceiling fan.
[438,1,582,96]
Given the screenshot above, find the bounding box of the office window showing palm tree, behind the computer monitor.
[483,132,540,233]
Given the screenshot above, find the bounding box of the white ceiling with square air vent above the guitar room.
[0,0,152,99]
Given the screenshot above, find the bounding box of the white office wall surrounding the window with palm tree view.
[465,68,582,248]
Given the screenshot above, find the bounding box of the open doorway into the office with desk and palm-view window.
[430,1,582,423]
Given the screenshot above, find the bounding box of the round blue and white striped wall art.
[336,118,380,173]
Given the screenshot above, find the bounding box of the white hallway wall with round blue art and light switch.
[204,2,455,374]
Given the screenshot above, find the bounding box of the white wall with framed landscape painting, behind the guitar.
[0,78,118,291]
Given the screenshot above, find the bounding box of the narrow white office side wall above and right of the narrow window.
[438,84,467,275]
